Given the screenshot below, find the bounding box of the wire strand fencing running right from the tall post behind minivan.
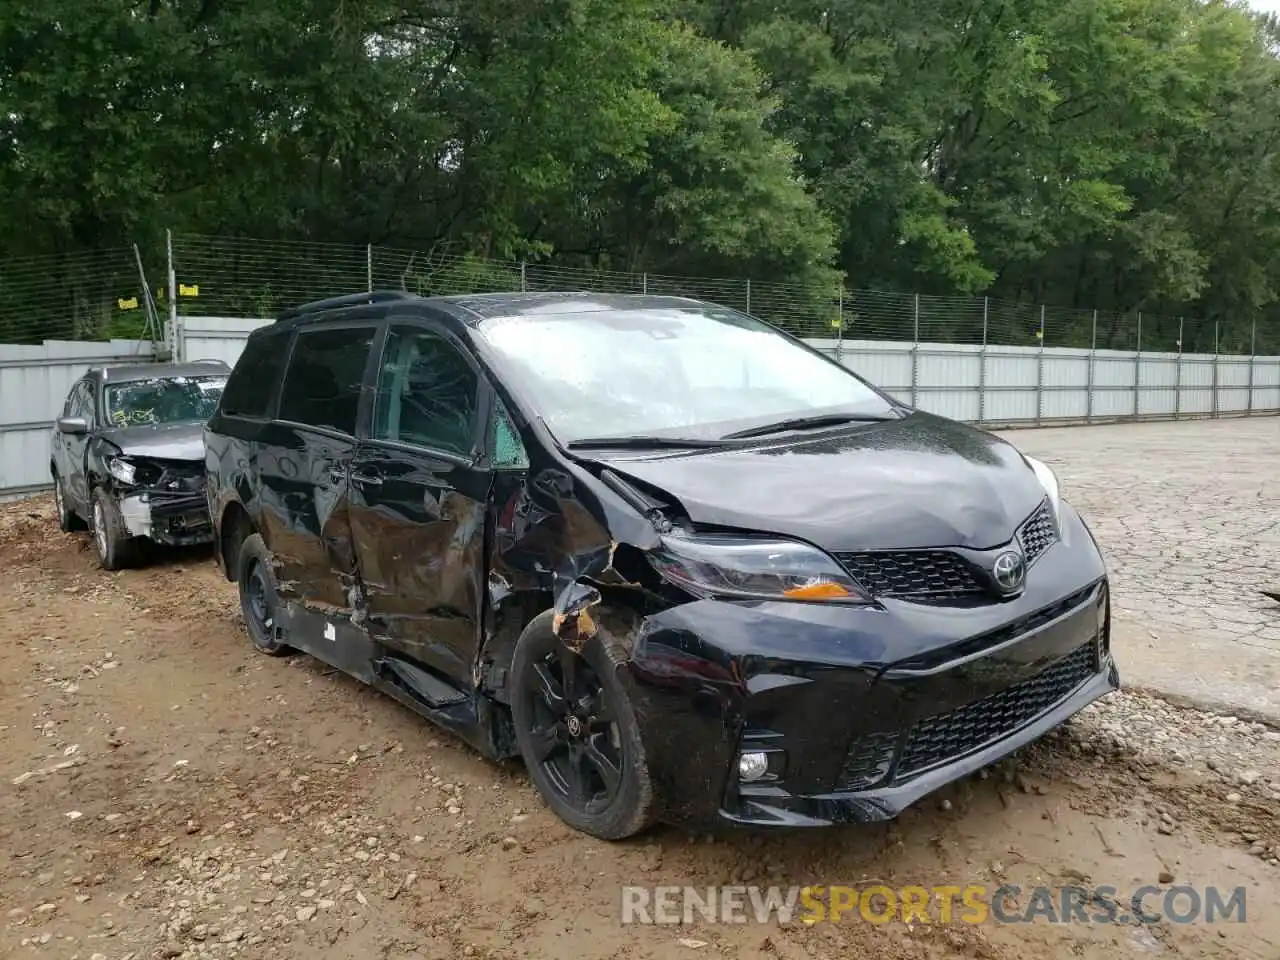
[173,234,1280,356]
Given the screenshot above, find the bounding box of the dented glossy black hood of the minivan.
[596,412,1046,552]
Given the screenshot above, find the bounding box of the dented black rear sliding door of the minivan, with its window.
[259,321,379,611]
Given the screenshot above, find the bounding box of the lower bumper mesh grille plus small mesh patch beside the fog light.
[836,641,1096,791]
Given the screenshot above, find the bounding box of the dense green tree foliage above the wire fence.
[0,0,1280,349]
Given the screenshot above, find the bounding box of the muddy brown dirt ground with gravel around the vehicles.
[0,499,1280,960]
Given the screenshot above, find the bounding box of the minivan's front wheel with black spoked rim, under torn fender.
[511,611,655,840]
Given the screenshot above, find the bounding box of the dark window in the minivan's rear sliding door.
[280,326,378,434]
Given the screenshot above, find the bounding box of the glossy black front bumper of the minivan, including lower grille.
[614,511,1120,827]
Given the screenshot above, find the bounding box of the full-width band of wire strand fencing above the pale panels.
[0,234,1280,356]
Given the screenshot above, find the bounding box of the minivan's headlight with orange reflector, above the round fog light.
[649,535,872,603]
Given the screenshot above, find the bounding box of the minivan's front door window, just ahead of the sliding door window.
[374,328,480,457]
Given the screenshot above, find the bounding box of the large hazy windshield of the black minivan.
[479,306,893,443]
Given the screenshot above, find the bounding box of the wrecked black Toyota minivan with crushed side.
[205,293,1119,840]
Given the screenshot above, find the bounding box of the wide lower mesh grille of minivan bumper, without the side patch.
[897,643,1094,778]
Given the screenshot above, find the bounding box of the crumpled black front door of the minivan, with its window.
[349,317,492,689]
